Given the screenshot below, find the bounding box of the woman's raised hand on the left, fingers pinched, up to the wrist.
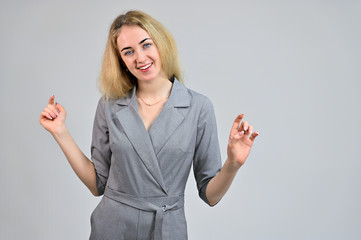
[39,95,66,135]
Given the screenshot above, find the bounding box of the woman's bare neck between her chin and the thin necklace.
[137,78,172,100]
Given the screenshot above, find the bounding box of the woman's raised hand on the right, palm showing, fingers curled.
[227,114,259,170]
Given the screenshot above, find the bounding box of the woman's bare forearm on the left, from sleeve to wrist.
[52,128,99,196]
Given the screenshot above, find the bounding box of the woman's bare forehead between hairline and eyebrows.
[117,25,150,49]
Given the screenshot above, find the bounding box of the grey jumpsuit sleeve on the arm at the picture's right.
[193,98,222,205]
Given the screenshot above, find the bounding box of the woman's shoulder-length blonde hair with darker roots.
[100,11,183,99]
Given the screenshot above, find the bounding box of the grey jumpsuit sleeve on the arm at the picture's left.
[91,99,111,195]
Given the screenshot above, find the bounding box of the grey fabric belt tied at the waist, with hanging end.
[104,187,184,240]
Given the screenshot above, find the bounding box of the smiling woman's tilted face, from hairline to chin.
[117,25,166,81]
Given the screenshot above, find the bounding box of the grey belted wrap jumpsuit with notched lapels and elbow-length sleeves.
[90,79,221,240]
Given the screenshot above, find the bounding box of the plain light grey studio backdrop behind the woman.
[0,0,361,240]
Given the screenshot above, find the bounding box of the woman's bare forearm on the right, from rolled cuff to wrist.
[206,159,239,206]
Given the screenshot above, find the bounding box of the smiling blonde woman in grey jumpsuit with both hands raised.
[40,11,258,240]
